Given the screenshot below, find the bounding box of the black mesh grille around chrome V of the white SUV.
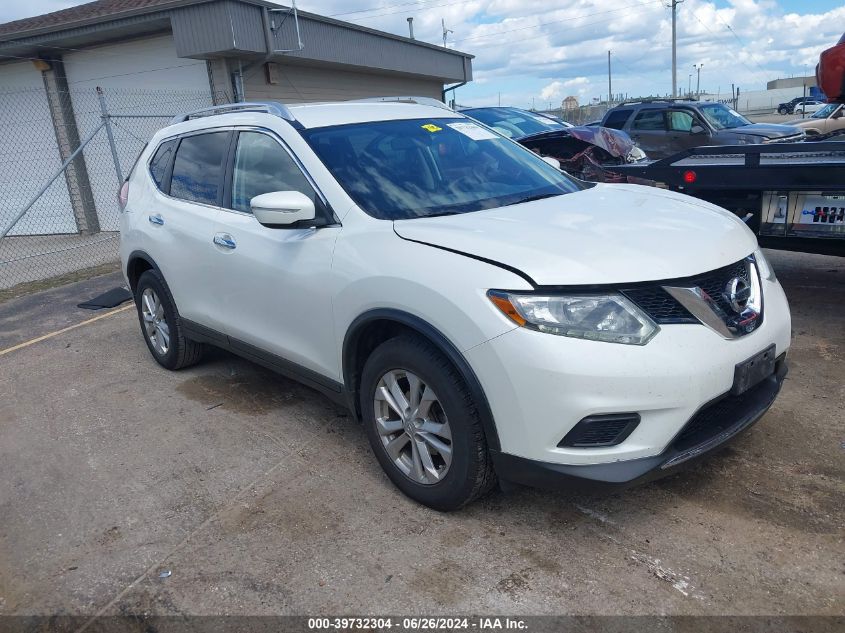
[622,259,750,324]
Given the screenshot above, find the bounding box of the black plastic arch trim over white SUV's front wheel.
[342,308,501,450]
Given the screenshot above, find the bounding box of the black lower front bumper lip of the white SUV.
[492,355,788,492]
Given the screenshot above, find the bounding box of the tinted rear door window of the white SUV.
[170,132,229,204]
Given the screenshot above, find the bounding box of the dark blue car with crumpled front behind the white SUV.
[461,107,646,182]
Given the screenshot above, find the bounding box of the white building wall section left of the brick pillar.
[0,61,76,235]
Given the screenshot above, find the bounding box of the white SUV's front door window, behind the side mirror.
[231,132,317,213]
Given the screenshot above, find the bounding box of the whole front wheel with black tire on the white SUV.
[359,336,496,511]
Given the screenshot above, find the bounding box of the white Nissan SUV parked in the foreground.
[120,102,790,510]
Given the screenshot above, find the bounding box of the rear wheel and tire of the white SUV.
[135,270,203,370]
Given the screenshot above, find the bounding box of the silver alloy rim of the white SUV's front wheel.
[373,369,452,485]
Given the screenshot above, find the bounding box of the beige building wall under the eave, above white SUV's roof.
[244,64,443,103]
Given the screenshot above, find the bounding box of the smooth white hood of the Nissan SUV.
[394,184,757,286]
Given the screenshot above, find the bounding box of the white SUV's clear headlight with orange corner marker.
[487,290,660,345]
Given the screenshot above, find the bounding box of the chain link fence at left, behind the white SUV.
[0,87,226,291]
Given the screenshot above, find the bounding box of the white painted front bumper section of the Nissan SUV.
[465,280,791,471]
